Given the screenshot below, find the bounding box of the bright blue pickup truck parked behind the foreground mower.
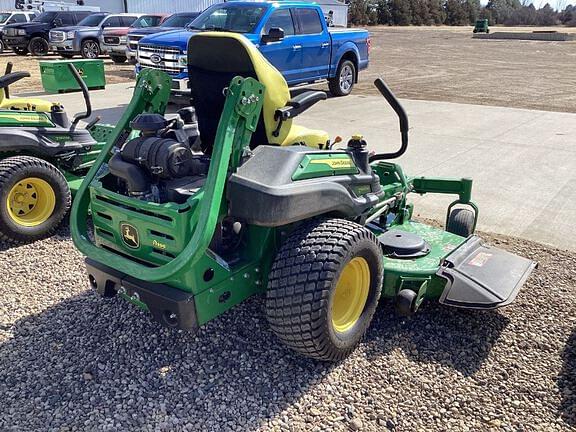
[136,1,370,96]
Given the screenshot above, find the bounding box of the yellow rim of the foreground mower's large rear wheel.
[332,257,370,332]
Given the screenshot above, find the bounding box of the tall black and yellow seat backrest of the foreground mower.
[188,32,292,153]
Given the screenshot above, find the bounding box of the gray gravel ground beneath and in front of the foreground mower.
[0,230,576,431]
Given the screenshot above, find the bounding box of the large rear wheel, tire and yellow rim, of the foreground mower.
[266,219,383,361]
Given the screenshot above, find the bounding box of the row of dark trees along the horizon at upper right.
[348,0,576,26]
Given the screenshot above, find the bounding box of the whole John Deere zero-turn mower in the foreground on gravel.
[71,32,534,361]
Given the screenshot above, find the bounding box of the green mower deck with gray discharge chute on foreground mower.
[376,221,535,309]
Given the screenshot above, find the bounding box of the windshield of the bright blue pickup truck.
[188,5,266,33]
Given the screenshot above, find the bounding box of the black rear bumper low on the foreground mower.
[86,258,199,331]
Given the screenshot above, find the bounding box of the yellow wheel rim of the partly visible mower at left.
[6,177,56,227]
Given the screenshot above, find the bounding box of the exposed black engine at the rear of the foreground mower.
[105,108,210,203]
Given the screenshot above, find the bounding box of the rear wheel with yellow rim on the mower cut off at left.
[0,156,72,243]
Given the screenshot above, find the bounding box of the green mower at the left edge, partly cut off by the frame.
[0,63,118,243]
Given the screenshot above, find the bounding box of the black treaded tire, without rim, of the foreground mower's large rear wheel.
[266,219,381,361]
